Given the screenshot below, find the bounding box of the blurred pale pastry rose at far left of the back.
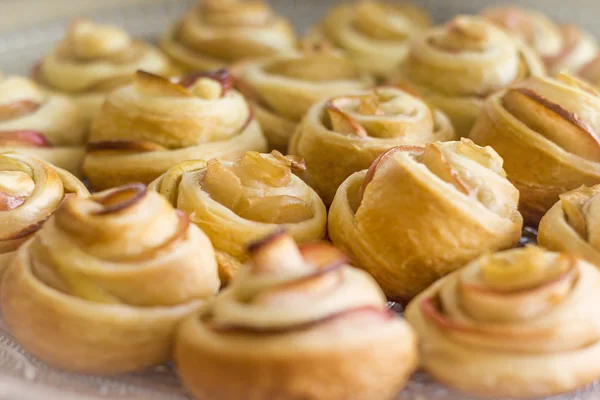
[33,20,175,119]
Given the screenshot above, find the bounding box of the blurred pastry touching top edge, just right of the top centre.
[311,0,432,77]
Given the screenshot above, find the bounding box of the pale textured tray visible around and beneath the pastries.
[0,0,600,400]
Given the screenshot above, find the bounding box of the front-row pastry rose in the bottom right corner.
[405,247,600,398]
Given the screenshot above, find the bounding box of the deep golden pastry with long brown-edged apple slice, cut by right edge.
[470,74,600,225]
